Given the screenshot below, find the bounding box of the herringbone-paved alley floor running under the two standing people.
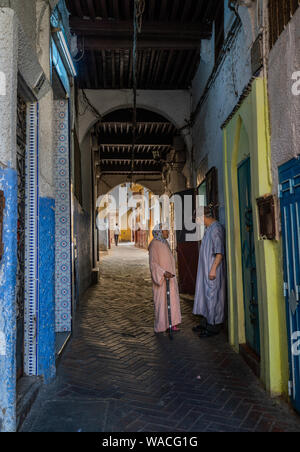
[22,246,300,432]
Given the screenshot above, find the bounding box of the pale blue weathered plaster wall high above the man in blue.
[192,8,253,224]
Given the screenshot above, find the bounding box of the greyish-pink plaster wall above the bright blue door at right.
[268,8,300,193]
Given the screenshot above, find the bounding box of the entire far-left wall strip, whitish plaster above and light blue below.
[0,9,18,432]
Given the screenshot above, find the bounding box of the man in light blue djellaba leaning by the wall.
[193,205,226,337]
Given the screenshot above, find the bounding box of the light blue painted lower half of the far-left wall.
[0,168,18,432]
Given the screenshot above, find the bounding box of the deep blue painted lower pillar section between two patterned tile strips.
[38,198,56,383]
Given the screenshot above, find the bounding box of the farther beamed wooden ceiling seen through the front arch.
[93,109,177,175]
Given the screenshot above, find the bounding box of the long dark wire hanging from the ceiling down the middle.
[131,0,146,180]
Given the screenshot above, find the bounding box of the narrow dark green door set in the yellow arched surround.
[238,158,260,356]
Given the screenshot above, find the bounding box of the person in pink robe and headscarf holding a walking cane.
[149,224,181,333]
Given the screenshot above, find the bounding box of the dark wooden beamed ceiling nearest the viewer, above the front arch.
[66,0,221,89]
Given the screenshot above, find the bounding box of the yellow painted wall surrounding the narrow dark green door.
[224,78,288,395]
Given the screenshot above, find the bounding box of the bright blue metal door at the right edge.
[279,159,300,412]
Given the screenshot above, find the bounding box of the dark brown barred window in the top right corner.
[269,0,300,48]
